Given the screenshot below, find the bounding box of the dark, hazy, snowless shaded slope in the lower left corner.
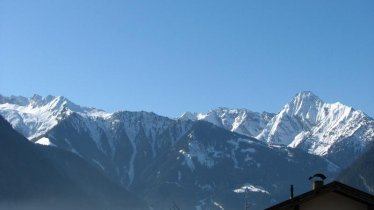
[0,117,146,210]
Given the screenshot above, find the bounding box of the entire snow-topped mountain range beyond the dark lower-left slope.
[0,92,374,209]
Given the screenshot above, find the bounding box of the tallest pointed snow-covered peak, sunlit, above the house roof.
[256,92,374,166]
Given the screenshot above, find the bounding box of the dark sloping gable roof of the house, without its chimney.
[265,181,374,210]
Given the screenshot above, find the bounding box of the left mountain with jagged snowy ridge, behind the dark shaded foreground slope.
[0,95,196,186]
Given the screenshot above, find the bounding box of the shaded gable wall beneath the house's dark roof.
[299,192,367,210]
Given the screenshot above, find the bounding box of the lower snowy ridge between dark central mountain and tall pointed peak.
[179,108,274,136]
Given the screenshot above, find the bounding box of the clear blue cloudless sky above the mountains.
[0,0,374,117]
